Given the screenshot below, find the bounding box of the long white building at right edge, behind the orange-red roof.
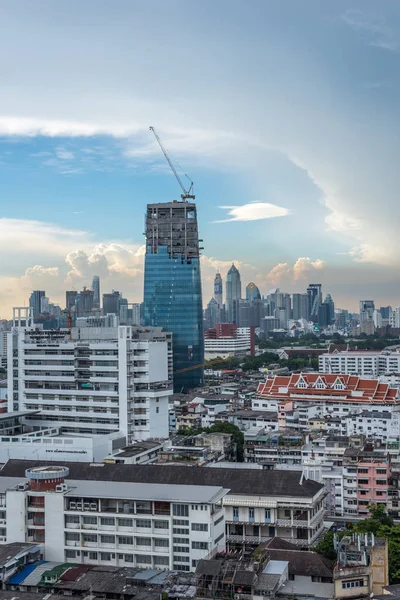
[318,350,400,377]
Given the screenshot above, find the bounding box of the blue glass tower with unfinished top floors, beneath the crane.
[144,201,204,392]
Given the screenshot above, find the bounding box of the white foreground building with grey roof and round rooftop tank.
[0,463,227,571]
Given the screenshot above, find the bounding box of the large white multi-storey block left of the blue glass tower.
[8,309,172,443]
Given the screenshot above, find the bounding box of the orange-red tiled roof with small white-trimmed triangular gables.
[257,373,400,404]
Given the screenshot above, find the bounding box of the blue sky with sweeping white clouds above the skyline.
[0,0,400,318]
